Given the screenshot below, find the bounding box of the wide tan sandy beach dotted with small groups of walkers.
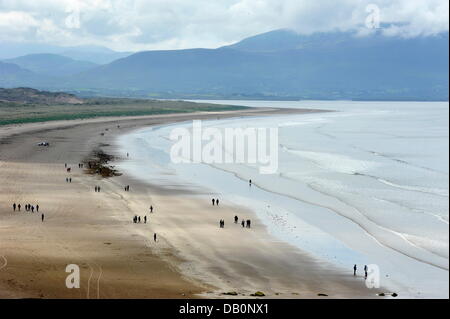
[0,108,380,299]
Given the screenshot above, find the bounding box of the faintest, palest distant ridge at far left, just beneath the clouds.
[0,42,132,64]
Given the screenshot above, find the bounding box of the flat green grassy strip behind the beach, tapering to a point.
[0,98,246,125]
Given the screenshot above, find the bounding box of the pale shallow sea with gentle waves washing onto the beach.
[119,101,449,298]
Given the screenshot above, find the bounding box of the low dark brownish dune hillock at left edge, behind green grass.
[0,88,84,104]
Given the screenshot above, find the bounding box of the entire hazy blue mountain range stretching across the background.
[0,30,449,100]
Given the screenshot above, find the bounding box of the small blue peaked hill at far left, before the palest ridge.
[4,53,97,77]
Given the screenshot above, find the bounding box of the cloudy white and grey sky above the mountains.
[0,0,449,51]
